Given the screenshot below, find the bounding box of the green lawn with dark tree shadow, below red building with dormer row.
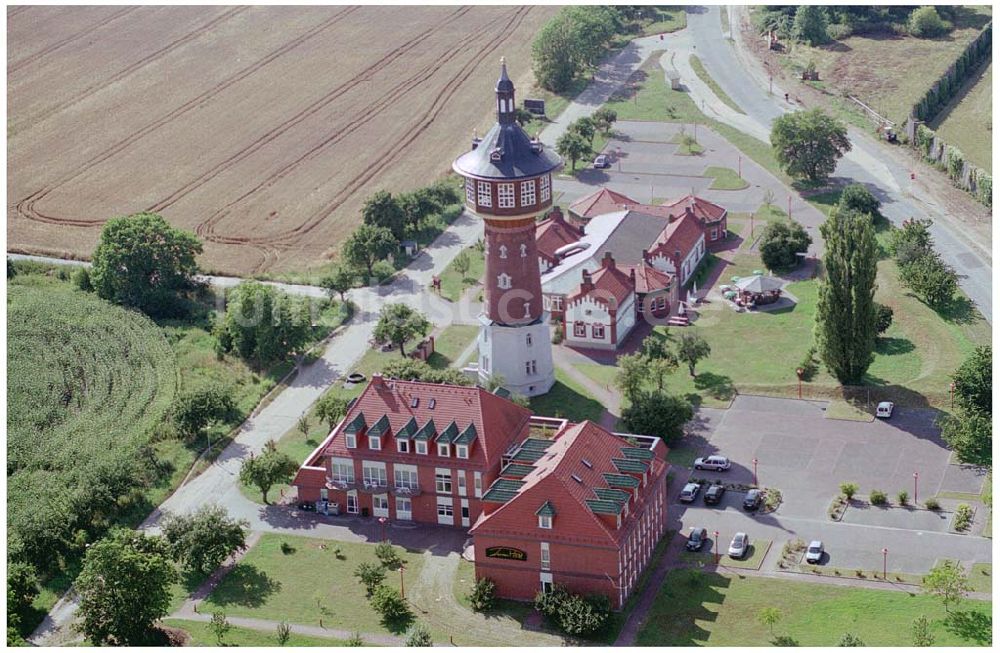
[198,533,424,633]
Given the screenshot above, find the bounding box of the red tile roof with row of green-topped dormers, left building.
[323,375,531,466]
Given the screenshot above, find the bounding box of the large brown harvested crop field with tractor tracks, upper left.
[7,6,557,275]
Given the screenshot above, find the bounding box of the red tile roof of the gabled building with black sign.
[472,421,667,546]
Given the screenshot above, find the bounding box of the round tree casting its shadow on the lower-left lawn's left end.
[163,505,250,574]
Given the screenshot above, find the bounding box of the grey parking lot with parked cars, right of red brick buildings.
[672,395,992,573]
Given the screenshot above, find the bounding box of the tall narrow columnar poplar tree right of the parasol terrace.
[815,209,878,384]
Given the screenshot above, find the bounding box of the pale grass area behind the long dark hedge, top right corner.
[928,63,993,172]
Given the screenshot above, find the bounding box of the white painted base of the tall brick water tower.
[479,311,556,397]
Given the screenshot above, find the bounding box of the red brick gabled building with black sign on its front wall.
[471,422,669,609]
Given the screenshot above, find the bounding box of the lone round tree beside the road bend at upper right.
[771,109,851,183]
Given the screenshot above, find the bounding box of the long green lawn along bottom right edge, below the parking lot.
[636,570,992,646]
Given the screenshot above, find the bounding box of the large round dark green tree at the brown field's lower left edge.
[90,213,202,315]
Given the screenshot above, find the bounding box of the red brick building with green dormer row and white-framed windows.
[292,374,531,527]
